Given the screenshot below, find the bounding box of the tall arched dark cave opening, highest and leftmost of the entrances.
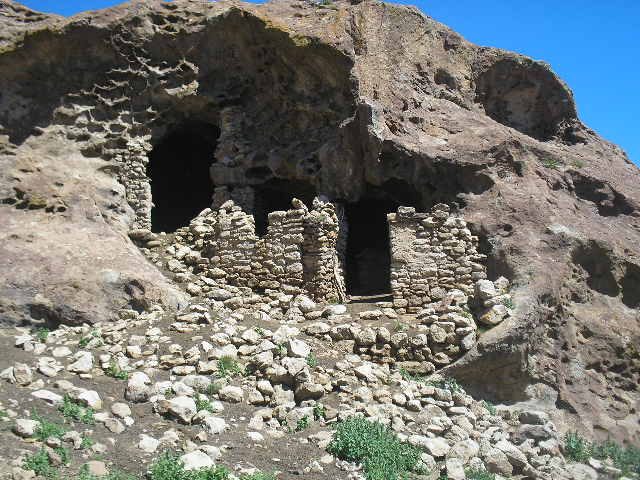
[147,122,220,232]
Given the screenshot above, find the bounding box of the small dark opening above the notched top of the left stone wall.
[253,178,316,236]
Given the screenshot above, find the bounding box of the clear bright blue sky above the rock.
[22,0,640,165]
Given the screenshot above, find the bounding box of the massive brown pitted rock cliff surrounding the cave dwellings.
[0,0,640,439]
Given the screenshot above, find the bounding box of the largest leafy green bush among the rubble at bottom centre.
[327,417,421,480]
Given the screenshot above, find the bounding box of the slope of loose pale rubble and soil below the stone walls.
[0,284,635,479]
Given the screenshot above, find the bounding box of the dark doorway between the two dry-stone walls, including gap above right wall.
[345,180,420,297]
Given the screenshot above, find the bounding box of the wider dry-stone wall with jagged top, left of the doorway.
[158,199,346,301]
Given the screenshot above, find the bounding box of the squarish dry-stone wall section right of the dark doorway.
[387,204,486,313]
